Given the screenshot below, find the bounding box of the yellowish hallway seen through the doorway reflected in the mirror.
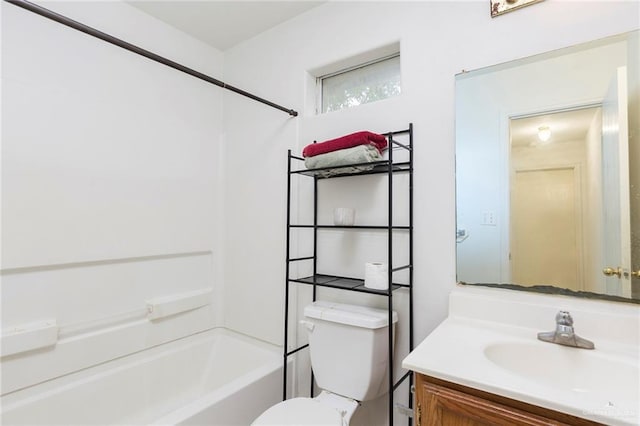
[510,106,604,292]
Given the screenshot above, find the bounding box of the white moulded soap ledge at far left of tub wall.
[0,319,58,357]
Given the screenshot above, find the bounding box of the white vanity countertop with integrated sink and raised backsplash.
[403,286,640,425]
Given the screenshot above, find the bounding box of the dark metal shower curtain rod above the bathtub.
[4,0,298,117]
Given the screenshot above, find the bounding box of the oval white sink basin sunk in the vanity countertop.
[484,341,640,403]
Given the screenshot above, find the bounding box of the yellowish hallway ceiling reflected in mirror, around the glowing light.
[510,108,598,146]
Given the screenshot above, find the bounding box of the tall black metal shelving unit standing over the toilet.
[282,123,413,426]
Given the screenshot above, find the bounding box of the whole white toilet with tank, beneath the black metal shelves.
[252,301,398,426]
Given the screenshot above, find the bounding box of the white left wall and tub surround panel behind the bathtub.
[1,2,223,392]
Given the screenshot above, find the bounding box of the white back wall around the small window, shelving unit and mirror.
[224,1,639,352]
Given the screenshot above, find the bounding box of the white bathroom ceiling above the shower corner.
[127,0,325,51]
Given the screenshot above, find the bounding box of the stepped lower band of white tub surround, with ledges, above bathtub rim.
[0,288,215,396]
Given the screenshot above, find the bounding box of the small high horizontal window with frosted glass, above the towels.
[318,54,401,113]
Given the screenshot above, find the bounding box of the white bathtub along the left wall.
[1,328,282,426]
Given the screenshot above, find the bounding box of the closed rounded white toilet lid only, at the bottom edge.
[251,398,343,426]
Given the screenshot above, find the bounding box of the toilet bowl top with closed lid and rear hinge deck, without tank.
[252,391,358,426]
